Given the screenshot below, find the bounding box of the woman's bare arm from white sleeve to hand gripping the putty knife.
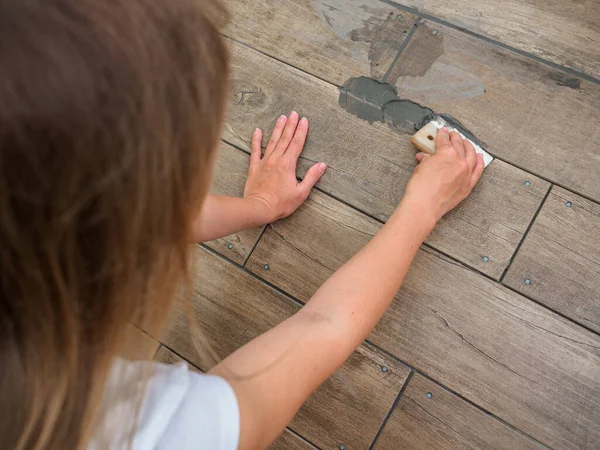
[211,129,483,450]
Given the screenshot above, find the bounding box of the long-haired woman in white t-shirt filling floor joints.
[0,0,483,450]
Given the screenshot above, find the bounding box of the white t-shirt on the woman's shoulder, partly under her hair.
[88,359,240,450]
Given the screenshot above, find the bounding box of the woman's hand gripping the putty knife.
[403,128,484,223]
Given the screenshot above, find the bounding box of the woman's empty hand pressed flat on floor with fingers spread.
[244,112,326,223]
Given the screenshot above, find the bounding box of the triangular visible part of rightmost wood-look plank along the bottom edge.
[374,374,547,450]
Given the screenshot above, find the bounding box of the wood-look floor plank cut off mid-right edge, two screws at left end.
[504,187,600,333]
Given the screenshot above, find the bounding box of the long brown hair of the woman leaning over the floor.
[0,0,228,449]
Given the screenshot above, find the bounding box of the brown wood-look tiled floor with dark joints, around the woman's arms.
[141,0,600,450]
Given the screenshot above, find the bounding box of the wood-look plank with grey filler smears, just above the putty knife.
[389,22,600,200]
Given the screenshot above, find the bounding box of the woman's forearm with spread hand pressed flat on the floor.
[193,112,325,242]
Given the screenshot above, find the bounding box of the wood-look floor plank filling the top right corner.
[397,0,600,78]
